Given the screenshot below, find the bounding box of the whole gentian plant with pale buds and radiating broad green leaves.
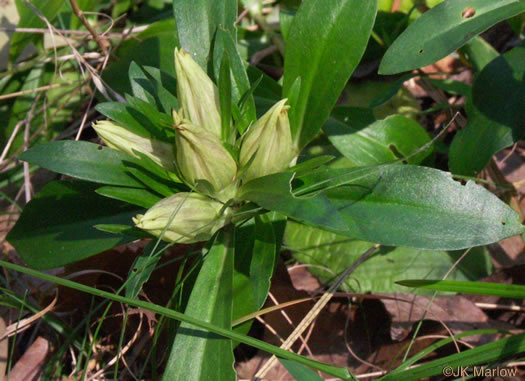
[8,0,525,380]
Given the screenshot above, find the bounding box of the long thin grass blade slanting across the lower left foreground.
[0,261,351,380]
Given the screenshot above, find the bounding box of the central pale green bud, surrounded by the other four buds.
[175,123,237,199]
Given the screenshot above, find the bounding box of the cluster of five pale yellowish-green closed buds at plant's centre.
[93,50,296,243]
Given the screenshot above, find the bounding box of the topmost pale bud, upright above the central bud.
[175,49,221,137]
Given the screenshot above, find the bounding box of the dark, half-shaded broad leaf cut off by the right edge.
[449,46,525,176]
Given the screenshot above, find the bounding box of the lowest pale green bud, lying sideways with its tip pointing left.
[133,193,231,243]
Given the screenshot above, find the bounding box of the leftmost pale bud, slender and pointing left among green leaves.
[93,120,175,172]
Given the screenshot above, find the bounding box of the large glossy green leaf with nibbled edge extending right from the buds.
[294,165,524,250]
